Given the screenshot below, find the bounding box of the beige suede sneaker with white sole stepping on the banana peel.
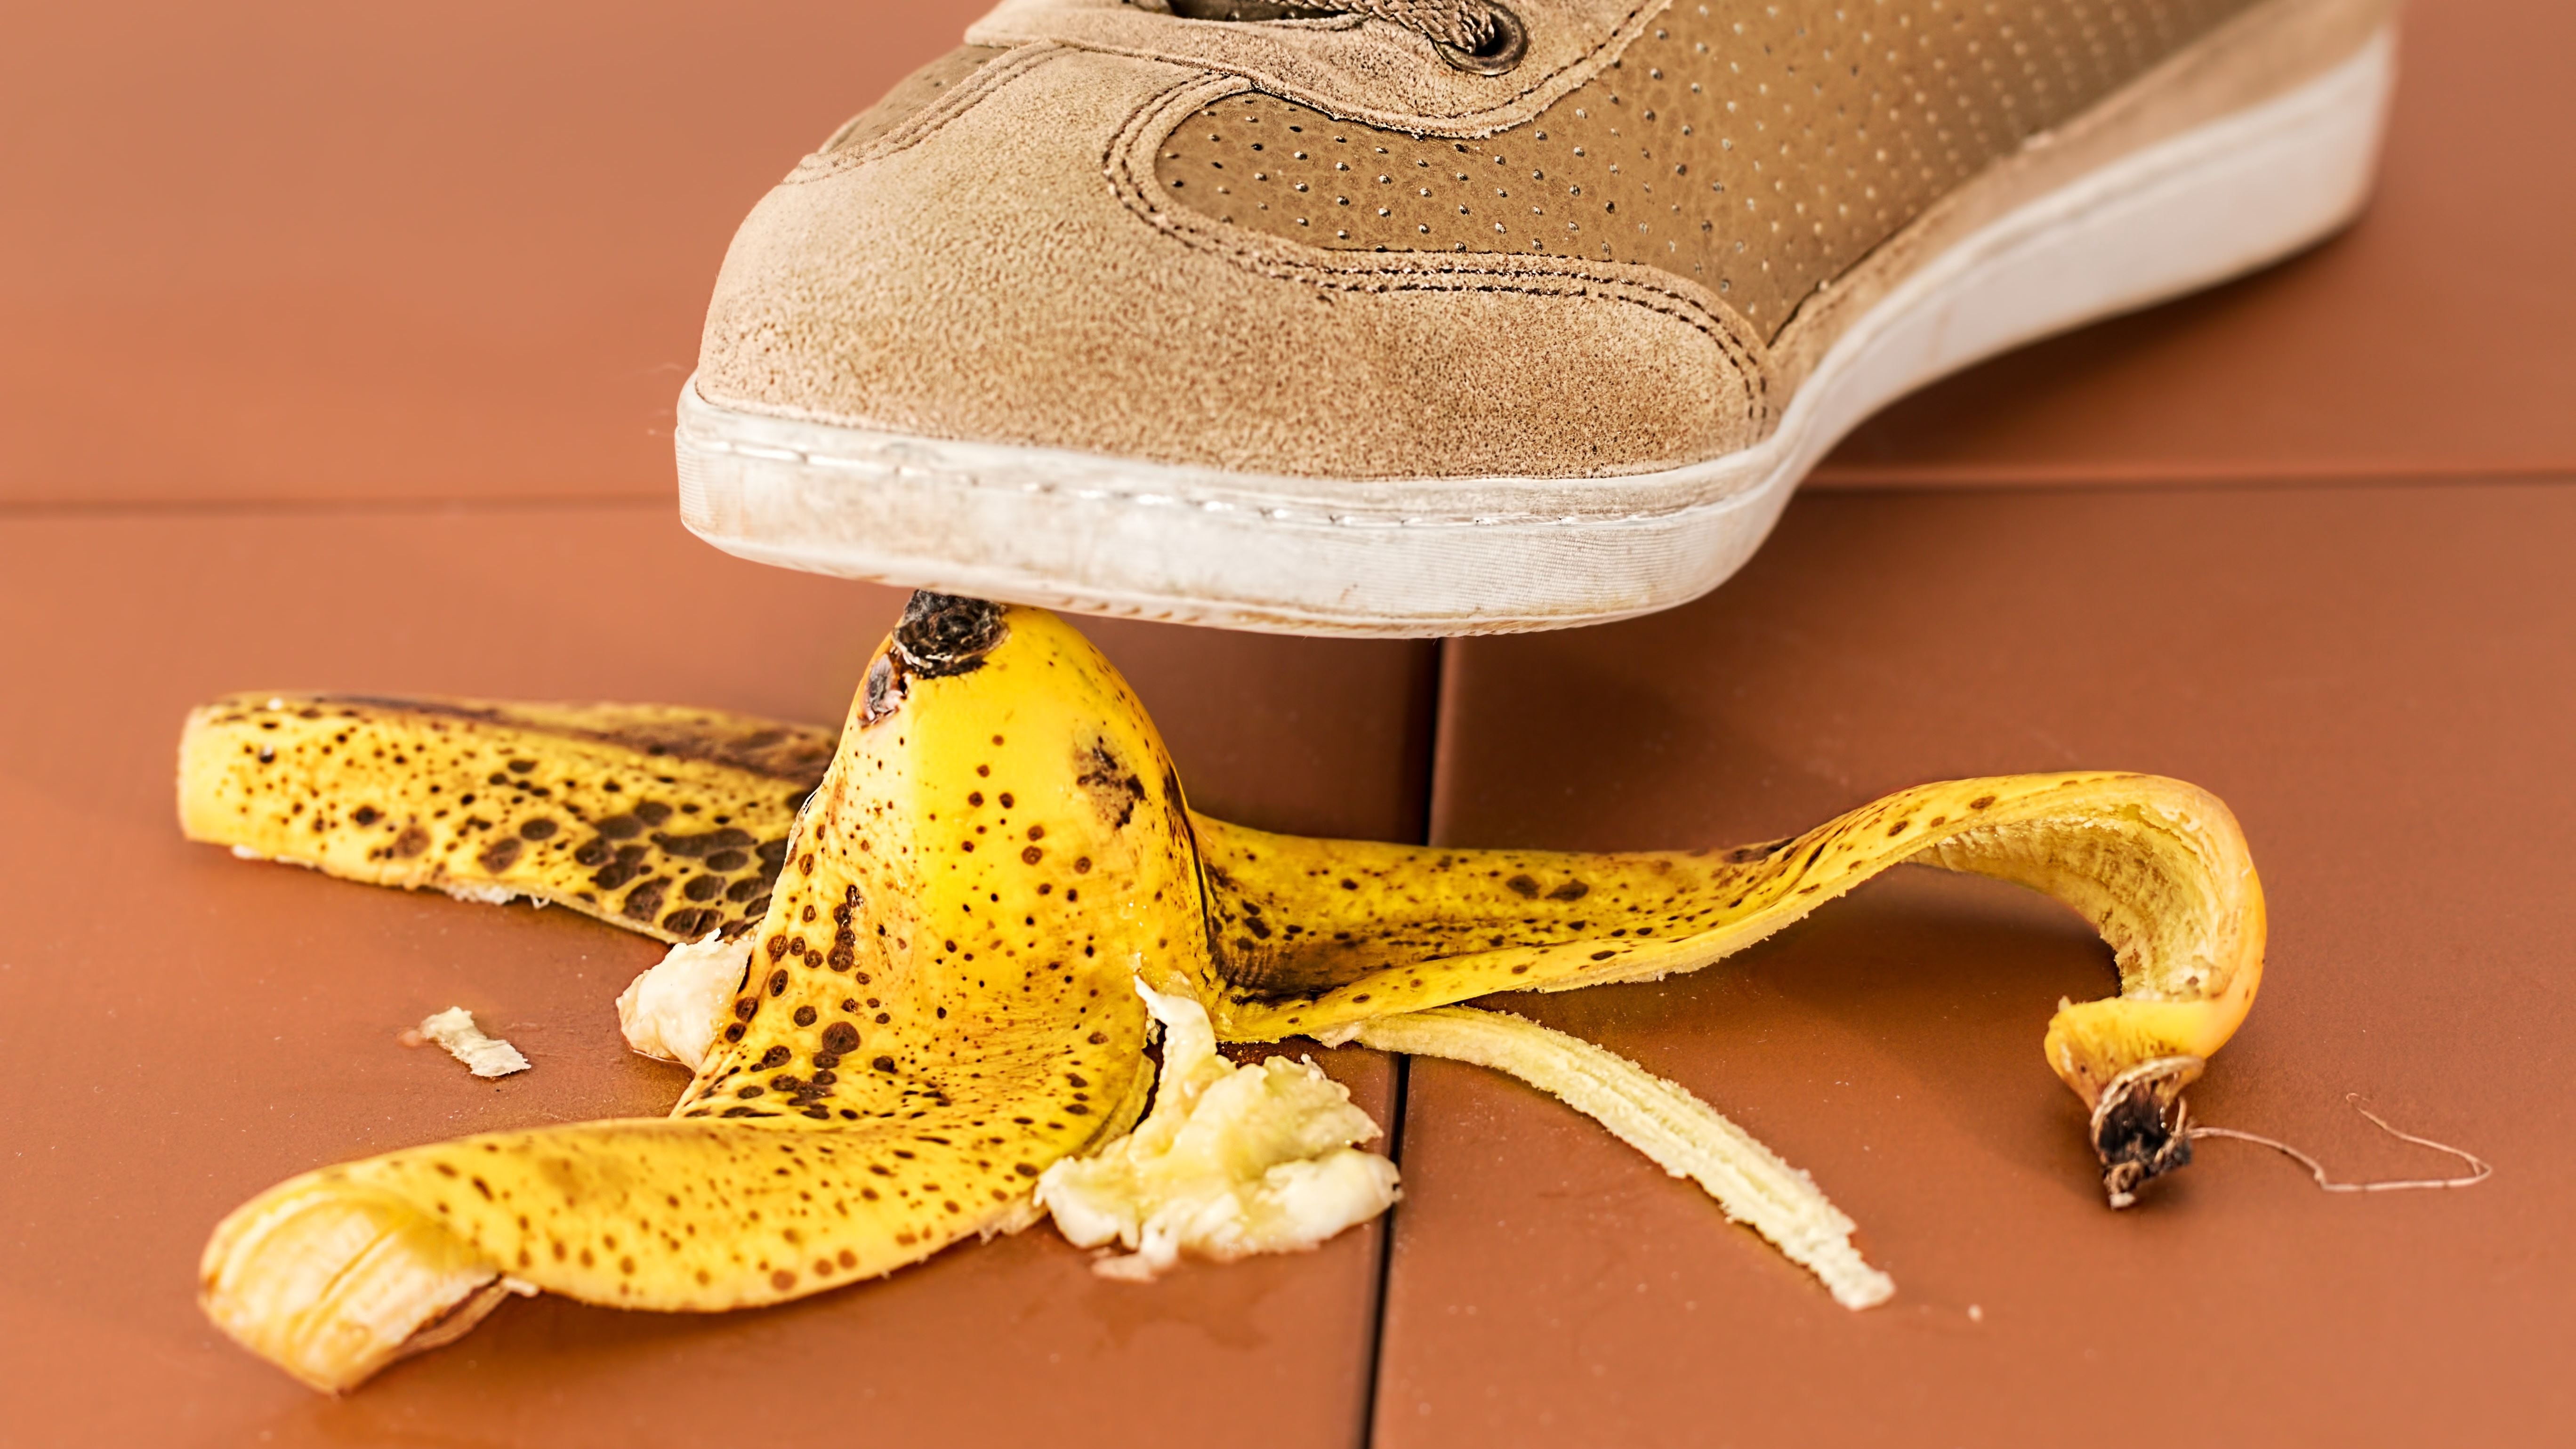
[677,0,2393,634]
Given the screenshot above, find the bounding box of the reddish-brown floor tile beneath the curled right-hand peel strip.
[1376,482,2576,1449]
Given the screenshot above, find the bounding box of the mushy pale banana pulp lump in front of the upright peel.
[1038,982,1399,1281]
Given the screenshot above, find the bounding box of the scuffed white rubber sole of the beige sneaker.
[675,31,2396,637]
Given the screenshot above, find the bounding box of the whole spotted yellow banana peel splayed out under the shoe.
[180,593,2264,1390]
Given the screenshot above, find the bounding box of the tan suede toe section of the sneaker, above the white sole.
[698,47,1764,477]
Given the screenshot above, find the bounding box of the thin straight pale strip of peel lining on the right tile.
[1352,1006,1896,1310]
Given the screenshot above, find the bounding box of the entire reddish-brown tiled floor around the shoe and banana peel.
[0,0,2576,1447]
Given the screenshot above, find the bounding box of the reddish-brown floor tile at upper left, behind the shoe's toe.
[0,0,989,505]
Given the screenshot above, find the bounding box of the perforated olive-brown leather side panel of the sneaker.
[1157,0,2254,335]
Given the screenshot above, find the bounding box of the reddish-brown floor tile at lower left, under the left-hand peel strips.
[0,503,1432,1449]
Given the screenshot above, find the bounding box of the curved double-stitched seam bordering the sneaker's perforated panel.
[1100,72,1772,428]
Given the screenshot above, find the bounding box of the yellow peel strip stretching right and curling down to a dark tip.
[1200,771,2267,1207]
